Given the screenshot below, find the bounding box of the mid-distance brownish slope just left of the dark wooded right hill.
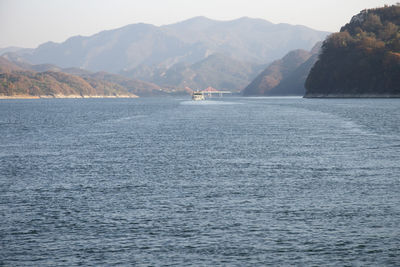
[242,49,312,96]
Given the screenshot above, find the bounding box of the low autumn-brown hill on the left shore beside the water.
[0,56,170,98]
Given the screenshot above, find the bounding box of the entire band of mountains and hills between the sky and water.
[0,7,400,97]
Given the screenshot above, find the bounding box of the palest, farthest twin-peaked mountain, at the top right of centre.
[163,17,328,64]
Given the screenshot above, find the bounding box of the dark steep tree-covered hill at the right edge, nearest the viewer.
[305,4,400,97]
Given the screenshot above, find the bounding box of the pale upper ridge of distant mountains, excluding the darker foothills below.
[9,17,328,78]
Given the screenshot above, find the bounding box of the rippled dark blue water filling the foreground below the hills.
[0,98,400,266]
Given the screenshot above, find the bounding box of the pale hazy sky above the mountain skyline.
[0,0,399,48]
